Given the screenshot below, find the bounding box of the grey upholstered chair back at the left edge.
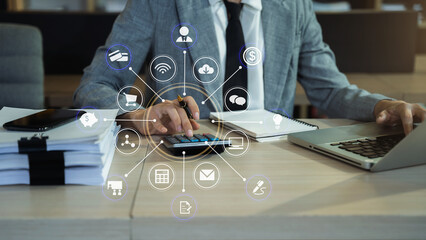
[0,23,44,109]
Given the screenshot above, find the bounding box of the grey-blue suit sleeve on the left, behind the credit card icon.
[74,0,155,115]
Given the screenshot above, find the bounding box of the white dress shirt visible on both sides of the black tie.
[209,0,264,109]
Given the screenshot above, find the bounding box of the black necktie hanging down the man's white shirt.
[223,0,247,111]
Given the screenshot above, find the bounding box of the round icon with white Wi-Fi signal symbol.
[149,55,177,83]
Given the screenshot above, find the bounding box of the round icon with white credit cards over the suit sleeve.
[105,44,132,70]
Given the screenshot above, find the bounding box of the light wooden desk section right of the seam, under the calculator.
[132,120,426,239]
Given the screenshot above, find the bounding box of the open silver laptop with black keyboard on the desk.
[288,122,426,172]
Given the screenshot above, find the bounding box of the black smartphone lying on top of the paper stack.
[3,109,86,132]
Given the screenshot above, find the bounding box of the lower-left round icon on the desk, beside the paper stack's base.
[102,175,128,201]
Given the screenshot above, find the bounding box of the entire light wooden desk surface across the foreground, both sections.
[0,120,426,239]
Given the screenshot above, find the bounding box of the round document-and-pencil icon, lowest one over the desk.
[170,194,198,221]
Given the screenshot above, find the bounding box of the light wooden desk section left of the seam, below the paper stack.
[0,137,147,240]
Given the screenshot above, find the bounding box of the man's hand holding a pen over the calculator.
[120,96,200,137]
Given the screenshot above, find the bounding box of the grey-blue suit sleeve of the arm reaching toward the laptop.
[298,0,389,121]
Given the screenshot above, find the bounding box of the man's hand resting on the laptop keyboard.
[374,100,426,135]
